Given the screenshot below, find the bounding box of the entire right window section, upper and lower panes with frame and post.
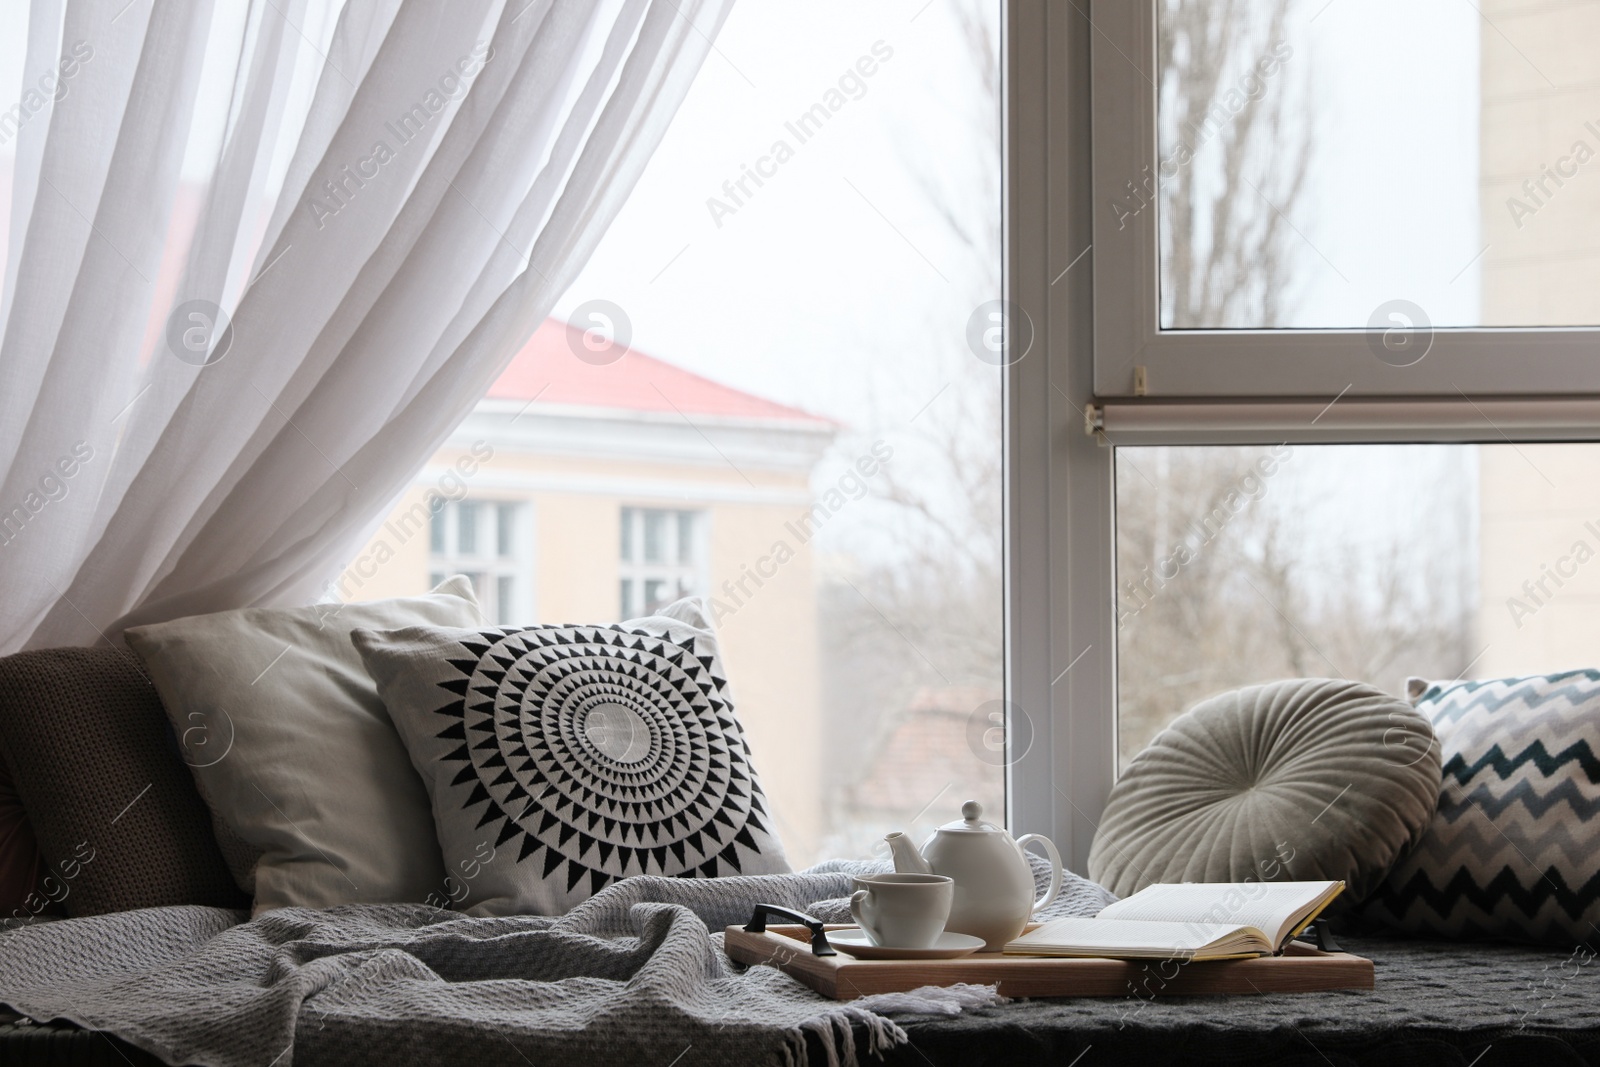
[1003,0,1600,864]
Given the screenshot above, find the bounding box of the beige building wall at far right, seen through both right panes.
[1470,0,1600,677]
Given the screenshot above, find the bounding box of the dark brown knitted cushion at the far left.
[0,648,250,917]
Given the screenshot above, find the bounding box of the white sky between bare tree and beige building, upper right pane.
[1290,0,1483,326]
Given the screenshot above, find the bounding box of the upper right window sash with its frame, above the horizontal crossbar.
[1090,0,1600,399]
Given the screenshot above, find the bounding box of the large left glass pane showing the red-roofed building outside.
[337,0,1005,867]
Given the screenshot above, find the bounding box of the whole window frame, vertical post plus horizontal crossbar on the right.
[1002,0,1600,872]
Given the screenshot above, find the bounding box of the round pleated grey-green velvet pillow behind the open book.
[1088,678,1440,901]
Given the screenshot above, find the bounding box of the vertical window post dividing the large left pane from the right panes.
[1002,0,1117,870]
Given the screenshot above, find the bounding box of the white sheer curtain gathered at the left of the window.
[0,0,733,653]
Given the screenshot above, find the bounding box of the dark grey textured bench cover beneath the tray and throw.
[12,937,1600,1067]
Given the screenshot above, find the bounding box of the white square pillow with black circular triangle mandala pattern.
[354,600,789,915]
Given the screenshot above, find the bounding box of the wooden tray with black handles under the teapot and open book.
[726,925,1373,1000]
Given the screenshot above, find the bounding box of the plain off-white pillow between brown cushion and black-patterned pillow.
[128,576,485,913]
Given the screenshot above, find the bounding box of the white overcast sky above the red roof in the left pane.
[557,0,1000,435]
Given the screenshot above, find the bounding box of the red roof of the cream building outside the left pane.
[486,318,834,426]
